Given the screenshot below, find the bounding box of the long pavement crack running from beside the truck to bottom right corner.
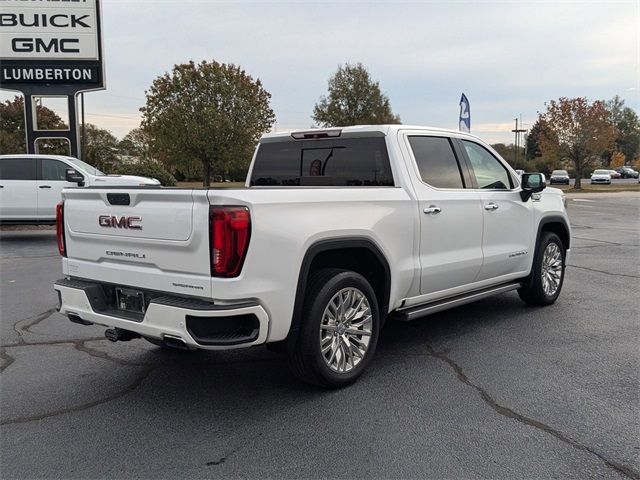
[427,345,640,480]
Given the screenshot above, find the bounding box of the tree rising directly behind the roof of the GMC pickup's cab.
[312,63,400,127]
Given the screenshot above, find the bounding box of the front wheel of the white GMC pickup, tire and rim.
[518,232,566,305]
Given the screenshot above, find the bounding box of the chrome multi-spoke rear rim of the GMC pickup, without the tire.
[320,287,373,373]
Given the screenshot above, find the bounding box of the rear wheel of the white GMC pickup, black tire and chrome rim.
[288,268,380,388]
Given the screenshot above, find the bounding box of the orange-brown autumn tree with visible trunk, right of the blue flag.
[538,97,615,189]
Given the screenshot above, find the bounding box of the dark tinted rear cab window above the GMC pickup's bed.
[249,137,395,187]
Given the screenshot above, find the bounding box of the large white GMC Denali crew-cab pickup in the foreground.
[55,125,571,387]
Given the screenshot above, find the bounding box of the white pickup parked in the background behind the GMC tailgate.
[0,154,160,223]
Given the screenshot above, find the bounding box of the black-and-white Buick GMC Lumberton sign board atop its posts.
[0,0,104,92]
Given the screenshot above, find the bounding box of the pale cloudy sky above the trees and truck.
[0,0,640,143]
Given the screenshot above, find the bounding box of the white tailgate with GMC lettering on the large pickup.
[63,188,211,297]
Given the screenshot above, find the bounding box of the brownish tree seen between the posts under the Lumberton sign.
[0,95,69,155]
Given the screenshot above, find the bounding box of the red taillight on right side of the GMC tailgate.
[209,207,251,278]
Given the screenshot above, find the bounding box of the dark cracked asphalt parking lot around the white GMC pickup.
[0,194,640,479]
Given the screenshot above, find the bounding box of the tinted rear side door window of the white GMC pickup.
[409,136,464,188]
